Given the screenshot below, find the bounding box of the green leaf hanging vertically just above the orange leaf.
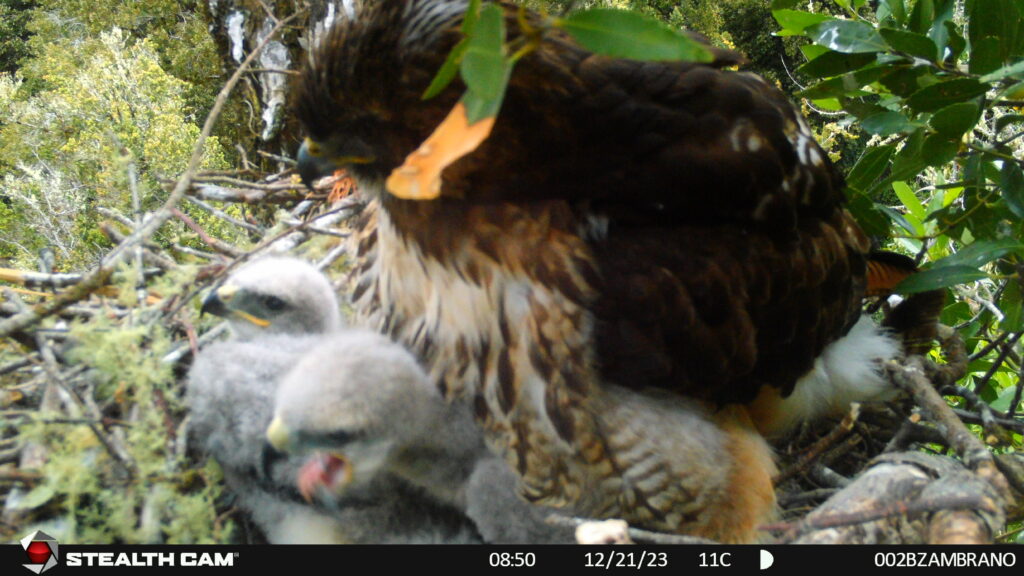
[460,4,512,100]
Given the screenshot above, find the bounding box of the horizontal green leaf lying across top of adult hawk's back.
[555,8,714,61]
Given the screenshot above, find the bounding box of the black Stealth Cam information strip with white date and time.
[0,543,1024,576]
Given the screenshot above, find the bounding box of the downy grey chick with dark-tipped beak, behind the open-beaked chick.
[187,257,479,544]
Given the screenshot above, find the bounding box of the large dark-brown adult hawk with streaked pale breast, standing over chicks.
[295,0,896,541]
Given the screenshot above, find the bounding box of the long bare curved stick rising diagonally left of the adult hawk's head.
[0,10,302,337]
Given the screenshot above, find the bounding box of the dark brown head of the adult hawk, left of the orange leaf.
[295,0,466,190]
